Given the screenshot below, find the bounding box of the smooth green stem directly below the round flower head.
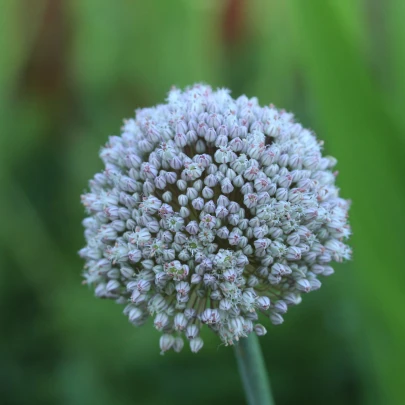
[234,333,274,405]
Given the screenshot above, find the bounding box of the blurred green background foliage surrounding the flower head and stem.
[0,0,405,405]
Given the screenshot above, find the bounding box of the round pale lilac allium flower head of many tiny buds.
[80,85,350,353]
